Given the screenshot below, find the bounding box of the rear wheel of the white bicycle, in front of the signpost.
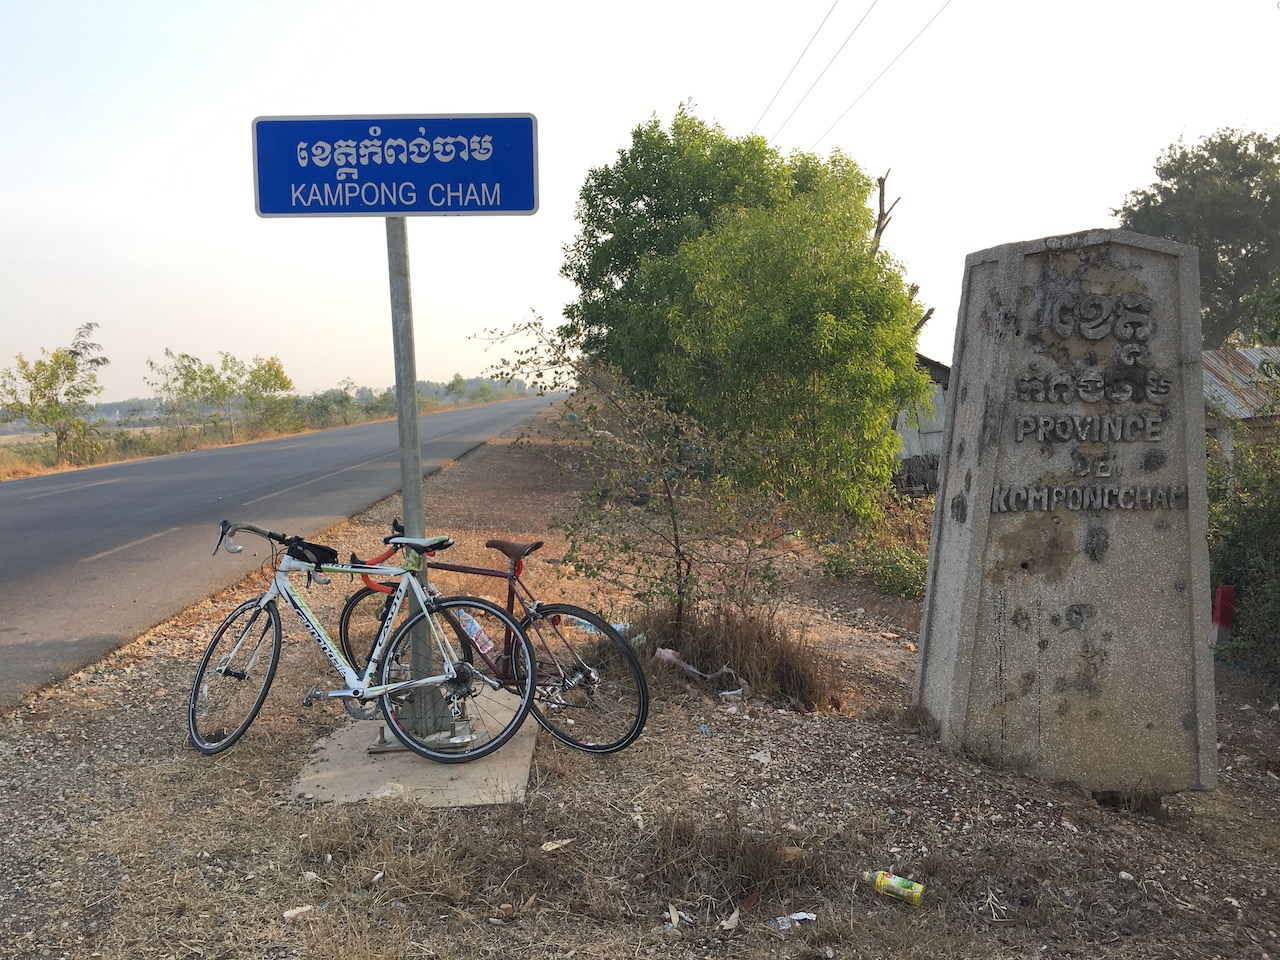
[379,596,534,763]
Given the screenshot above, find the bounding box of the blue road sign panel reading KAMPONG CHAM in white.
[253,114,538,216]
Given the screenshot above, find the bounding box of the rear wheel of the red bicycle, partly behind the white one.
[520,603,649,754]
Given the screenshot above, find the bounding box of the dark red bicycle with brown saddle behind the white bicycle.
[338,521,649,754]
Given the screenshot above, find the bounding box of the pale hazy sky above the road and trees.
[0,0,1280,401]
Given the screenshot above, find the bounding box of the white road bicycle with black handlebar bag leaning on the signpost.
[187,520,534,763]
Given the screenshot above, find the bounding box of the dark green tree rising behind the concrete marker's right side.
[1112,129,1280,348]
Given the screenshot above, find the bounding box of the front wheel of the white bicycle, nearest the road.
[187,599,282,755]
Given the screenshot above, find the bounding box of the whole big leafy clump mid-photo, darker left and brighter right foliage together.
[561,108,927,518]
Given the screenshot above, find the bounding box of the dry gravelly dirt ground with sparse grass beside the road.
[0,424,1280,960]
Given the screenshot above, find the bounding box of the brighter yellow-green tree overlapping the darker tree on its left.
[641,154,928,521]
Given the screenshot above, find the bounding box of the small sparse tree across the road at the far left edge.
[0,323,110,465]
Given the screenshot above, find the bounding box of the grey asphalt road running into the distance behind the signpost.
[0,398,560,709]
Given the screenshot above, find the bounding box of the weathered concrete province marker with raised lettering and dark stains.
[915,230,1216,794]
